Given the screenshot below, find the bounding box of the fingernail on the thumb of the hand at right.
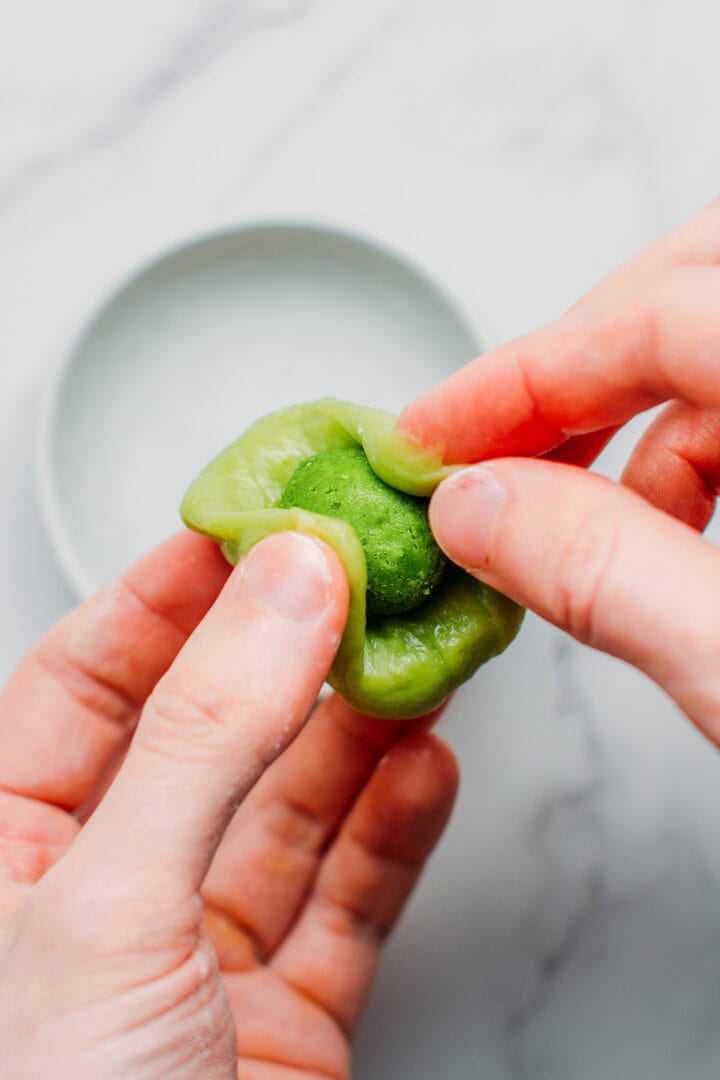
[430,465,505,569]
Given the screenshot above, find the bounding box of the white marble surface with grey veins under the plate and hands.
[0,0,720,1080]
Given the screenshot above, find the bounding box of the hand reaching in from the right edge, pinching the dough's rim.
[399,196,720,744]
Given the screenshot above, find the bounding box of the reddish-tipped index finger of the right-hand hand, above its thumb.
[398,267,720,463]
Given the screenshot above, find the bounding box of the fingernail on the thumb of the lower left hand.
[240,532,332,622]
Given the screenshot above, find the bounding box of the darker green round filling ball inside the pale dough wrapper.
[277,447,446,616]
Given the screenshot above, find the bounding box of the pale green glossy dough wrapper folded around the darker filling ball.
[180,399,524,719]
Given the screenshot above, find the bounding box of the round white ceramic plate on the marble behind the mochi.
[38,222,483,595]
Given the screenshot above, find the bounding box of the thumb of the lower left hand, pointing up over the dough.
[60,532,348,901]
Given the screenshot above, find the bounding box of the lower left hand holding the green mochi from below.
[0,534,457,1080]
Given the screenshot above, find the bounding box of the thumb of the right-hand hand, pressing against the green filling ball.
[430,459,720,743]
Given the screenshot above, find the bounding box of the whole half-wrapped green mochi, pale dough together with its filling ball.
[181,399,522,719]
